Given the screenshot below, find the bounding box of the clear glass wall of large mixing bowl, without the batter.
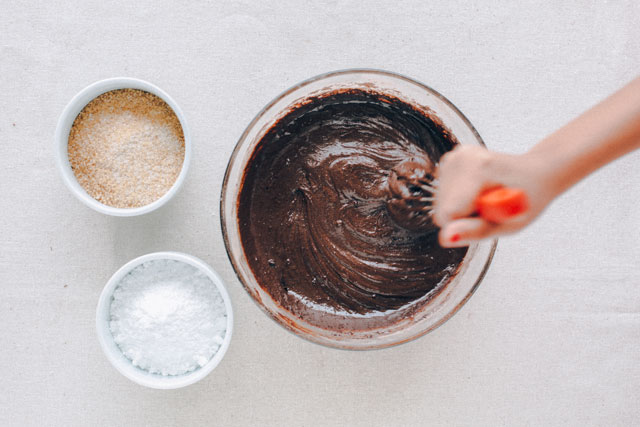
[220,69,497,350]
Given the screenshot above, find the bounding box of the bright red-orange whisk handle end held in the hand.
[476,187,529,224]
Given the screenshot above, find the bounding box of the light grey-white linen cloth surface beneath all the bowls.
[0,0,640,426]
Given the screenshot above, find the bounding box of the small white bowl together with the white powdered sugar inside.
[97,252,233,388]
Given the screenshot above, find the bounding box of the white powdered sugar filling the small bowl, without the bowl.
[110,259,227,375]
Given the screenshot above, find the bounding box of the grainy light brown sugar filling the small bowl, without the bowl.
[67,89,184,208]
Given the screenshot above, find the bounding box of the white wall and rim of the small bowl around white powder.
[96,252,233,389]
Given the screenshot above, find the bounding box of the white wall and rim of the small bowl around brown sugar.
[55,77,191,216]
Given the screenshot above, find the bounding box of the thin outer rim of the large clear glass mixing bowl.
[220,68,498,351]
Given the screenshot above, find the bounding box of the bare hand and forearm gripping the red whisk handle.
[434,77,640,247]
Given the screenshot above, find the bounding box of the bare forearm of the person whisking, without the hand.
[525,77,640,196]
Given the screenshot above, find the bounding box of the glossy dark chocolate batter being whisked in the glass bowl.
[238,90,466,329]
